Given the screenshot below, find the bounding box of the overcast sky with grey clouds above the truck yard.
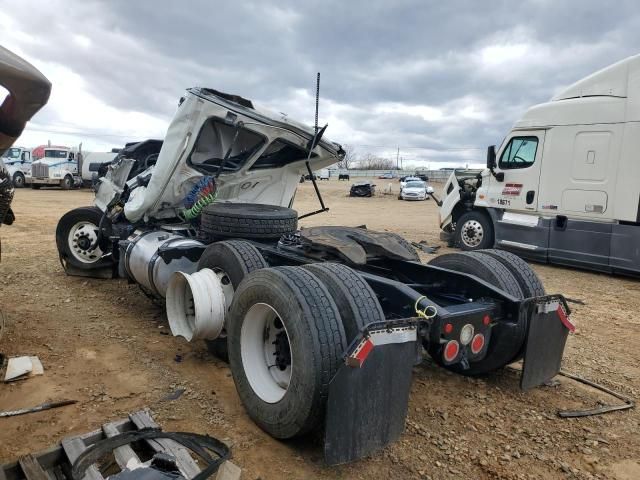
[0,0,640,168]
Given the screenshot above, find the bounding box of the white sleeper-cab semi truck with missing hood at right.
[440,55,640,275]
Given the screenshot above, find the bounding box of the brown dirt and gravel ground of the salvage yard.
[0,180,640,480]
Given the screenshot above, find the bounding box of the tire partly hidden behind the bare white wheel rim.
[198,240,269,362]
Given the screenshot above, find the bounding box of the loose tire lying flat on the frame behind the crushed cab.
[200,203,298,240]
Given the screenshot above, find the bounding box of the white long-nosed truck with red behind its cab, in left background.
[28,147,82,190]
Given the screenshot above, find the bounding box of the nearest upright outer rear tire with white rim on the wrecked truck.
[227,267,347,439]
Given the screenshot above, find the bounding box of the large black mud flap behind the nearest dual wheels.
[324,323,418,465]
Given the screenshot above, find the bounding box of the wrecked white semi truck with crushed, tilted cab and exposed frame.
[56,84,571,464]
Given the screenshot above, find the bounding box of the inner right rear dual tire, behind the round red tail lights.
[425,252,528,376]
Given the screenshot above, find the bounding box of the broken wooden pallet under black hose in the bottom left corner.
[0,411,200,480]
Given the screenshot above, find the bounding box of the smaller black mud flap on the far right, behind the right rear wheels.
[520,295,575,390]
